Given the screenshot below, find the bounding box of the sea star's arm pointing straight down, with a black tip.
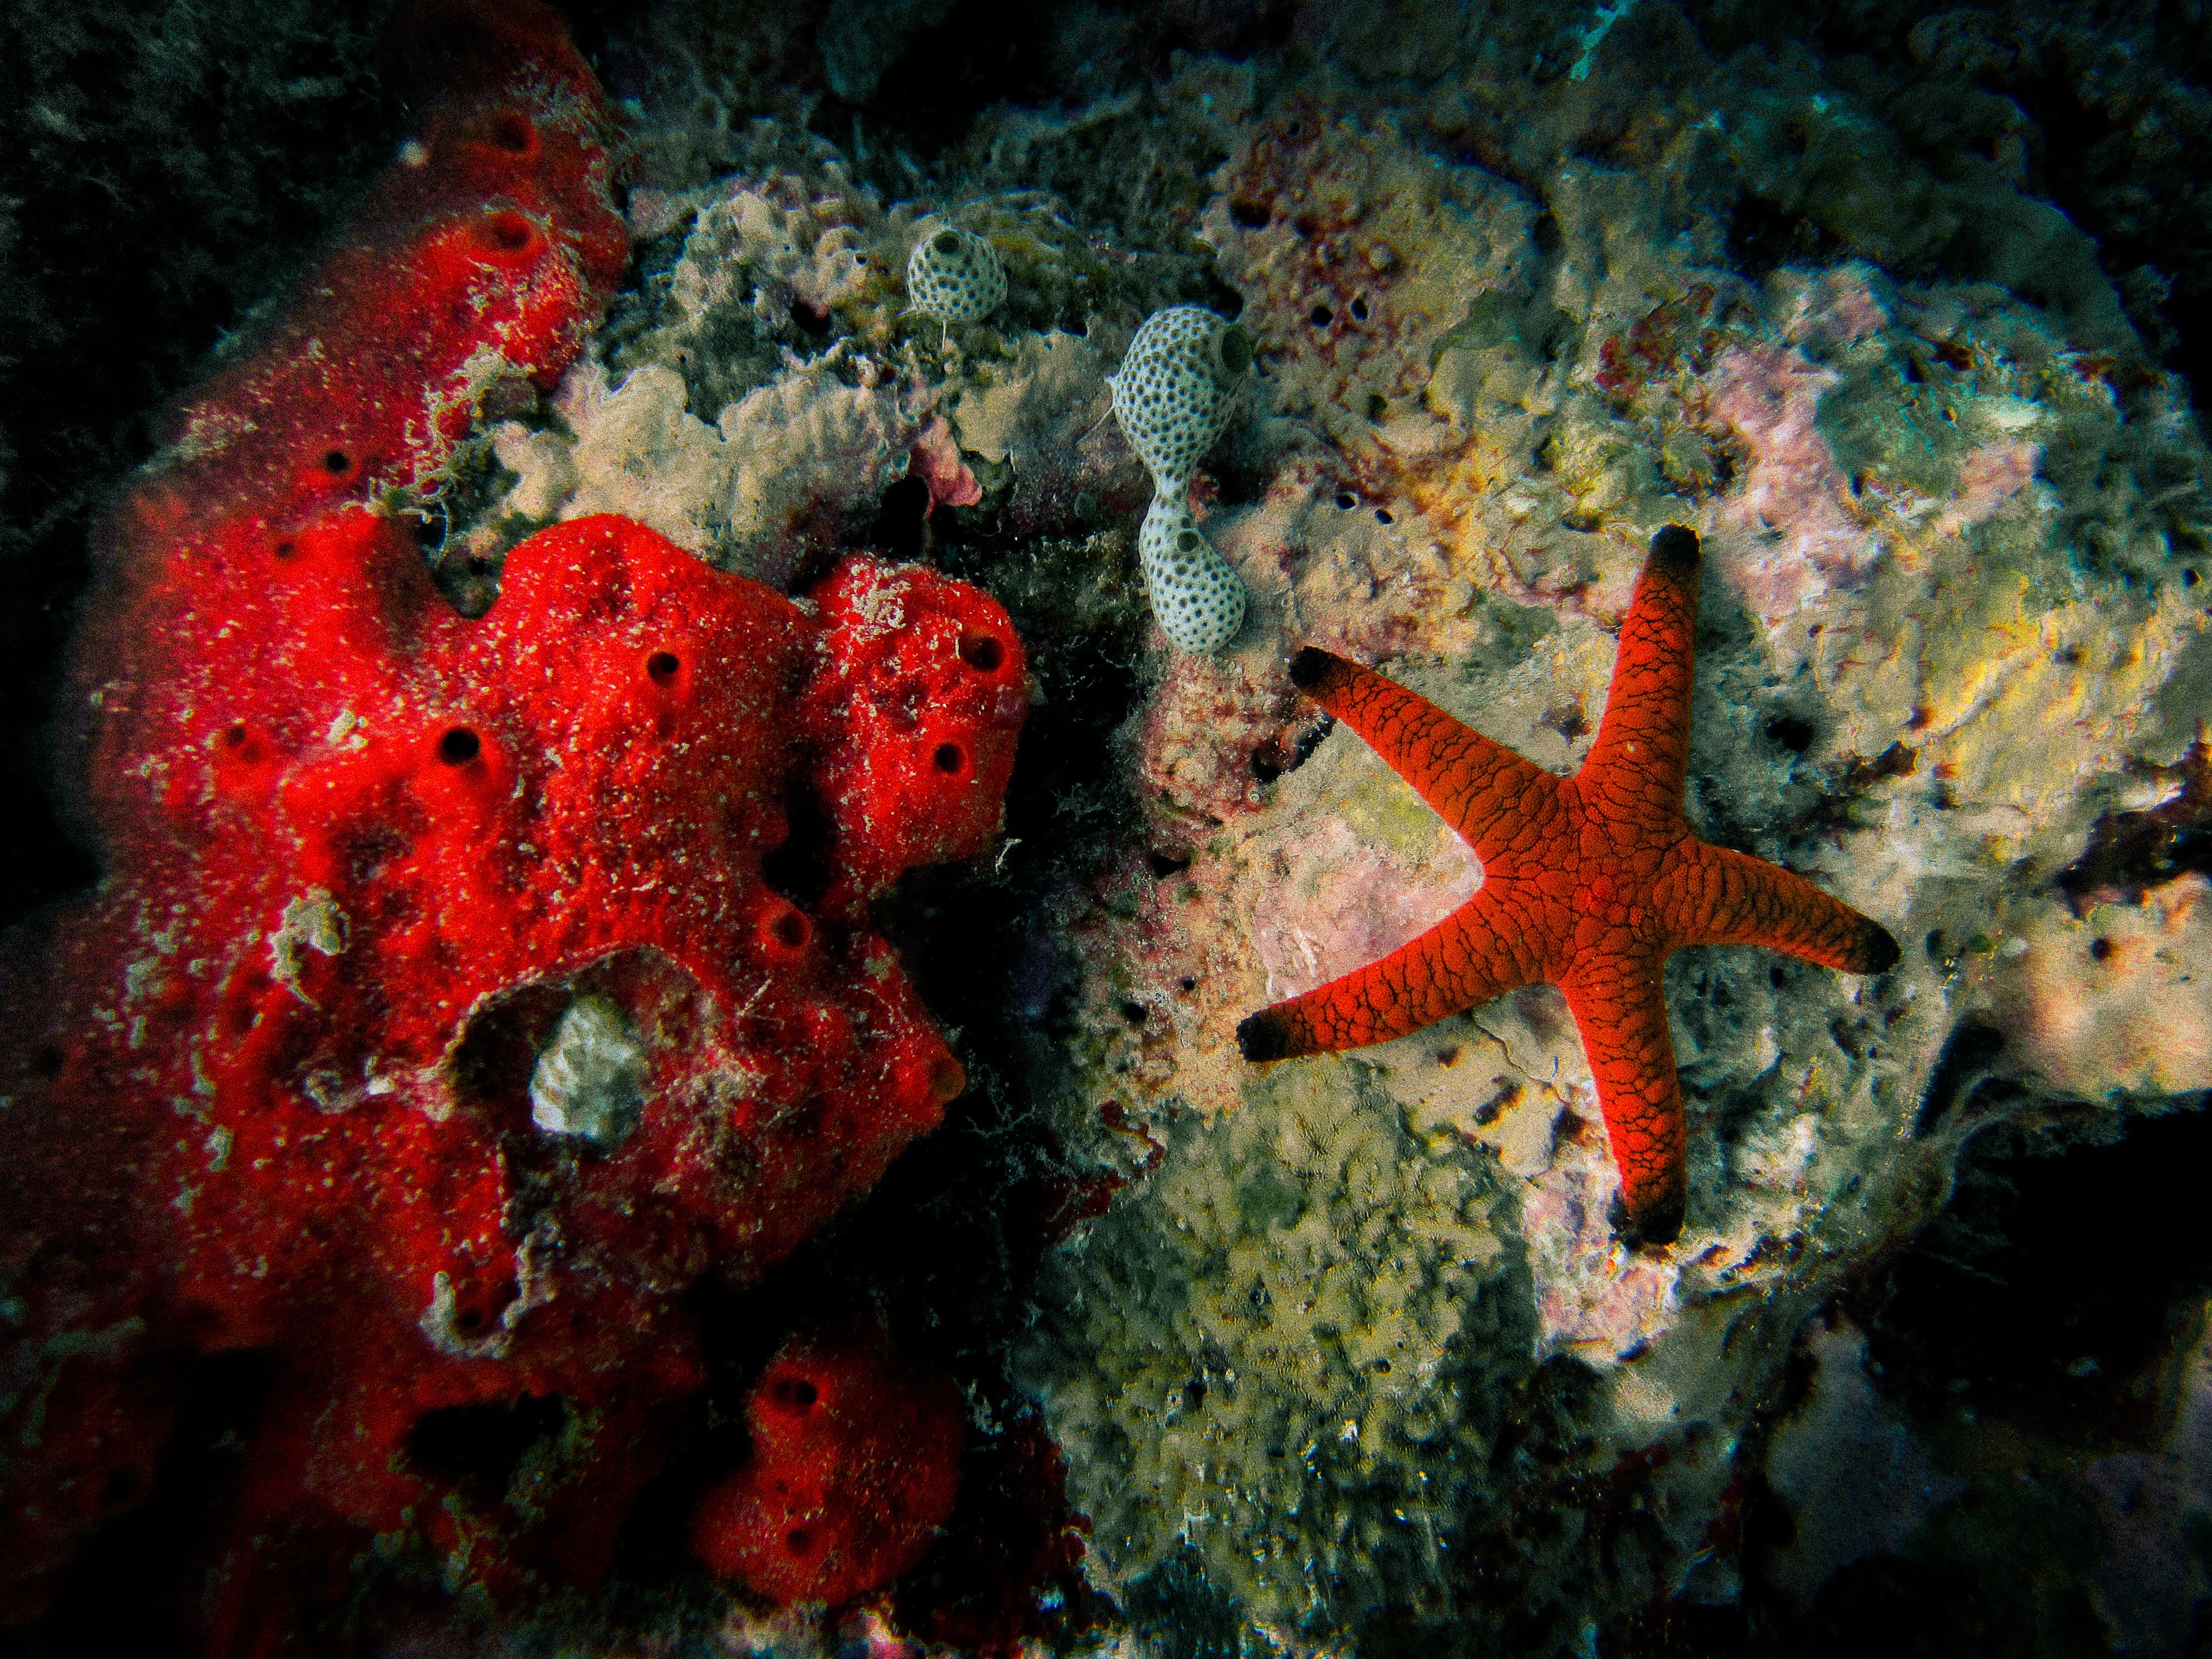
[1559,953,1690,1245]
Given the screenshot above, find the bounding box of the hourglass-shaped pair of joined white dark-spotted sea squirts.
[1113,305,1252,655]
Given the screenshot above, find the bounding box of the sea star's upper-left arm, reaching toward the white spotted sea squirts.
[1290,646,1557,858]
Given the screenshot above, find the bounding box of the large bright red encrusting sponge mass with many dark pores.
[0,5,1027,1654]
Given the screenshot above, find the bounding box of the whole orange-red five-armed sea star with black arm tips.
[1237,524,1898,1243]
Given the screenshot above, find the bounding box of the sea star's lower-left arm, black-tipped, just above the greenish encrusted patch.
[1237,893,1535,1059]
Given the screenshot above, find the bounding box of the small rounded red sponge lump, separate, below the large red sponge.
[692,1334,962,1606]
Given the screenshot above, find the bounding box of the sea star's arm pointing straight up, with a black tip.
[1582,524,1699,823]
